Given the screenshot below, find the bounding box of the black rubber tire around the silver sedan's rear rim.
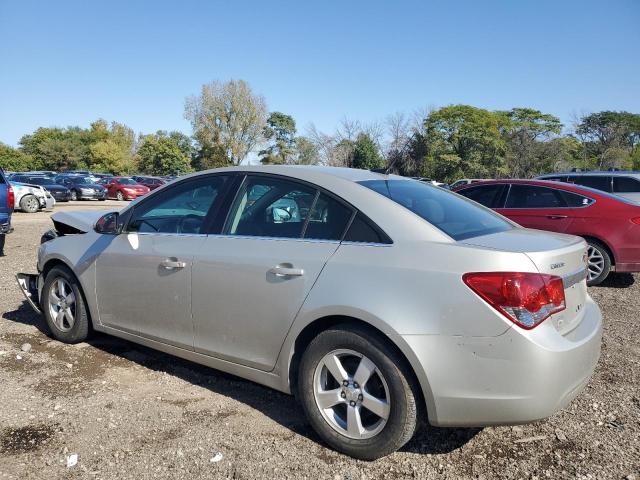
[298,325,421,460]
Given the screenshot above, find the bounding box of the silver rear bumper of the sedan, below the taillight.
[404,298,602,426]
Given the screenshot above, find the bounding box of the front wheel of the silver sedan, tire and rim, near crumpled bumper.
[40,266,89,343]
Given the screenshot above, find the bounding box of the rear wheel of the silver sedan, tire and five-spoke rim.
[298,326,420,460]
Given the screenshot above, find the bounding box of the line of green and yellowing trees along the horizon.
[0,80,640,182]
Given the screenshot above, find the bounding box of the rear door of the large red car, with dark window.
[496,183,573,233]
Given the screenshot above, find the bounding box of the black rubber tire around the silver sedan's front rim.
[40,266,91,343]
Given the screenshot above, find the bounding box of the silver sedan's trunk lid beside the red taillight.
[462,228,587,335]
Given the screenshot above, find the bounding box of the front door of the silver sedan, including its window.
[96,176,229,349]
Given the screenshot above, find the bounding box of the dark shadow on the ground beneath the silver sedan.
[2,302,481,454]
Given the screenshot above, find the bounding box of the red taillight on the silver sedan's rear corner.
[462,272,566,330]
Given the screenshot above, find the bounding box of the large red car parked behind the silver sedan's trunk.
[456,180,640,285]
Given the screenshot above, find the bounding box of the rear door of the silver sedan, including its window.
[192,175,353,371]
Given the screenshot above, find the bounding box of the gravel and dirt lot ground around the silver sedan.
[0,202,640,480]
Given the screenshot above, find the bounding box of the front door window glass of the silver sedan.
[127,176,228,234]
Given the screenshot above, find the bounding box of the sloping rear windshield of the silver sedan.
[359,180,515,240]
